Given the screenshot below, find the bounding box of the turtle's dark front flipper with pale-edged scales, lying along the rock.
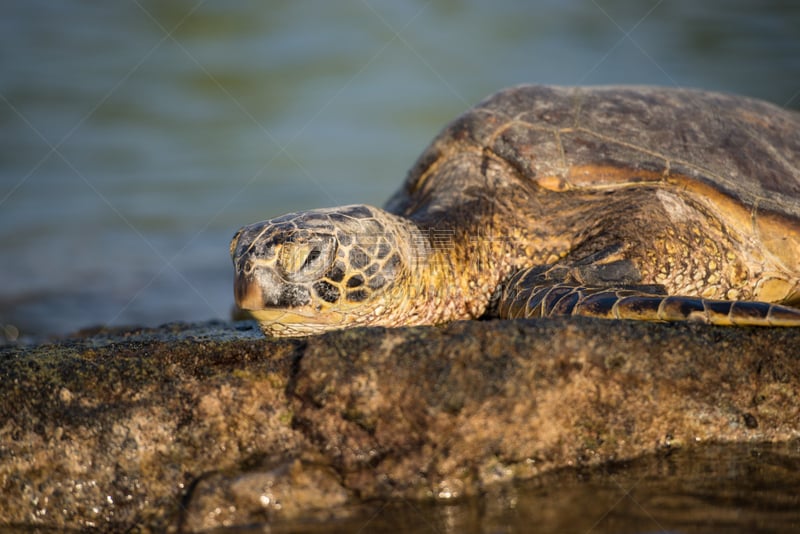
[497,268,800,326]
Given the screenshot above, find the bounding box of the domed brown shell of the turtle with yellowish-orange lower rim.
[387,85,800,272]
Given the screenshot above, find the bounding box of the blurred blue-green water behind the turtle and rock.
[0,0,800,335]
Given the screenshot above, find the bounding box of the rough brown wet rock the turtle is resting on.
[0,319,800,531]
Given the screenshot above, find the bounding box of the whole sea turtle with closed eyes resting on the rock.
[230,85,800,336]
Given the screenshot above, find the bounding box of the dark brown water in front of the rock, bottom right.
[270,442,800,534]
